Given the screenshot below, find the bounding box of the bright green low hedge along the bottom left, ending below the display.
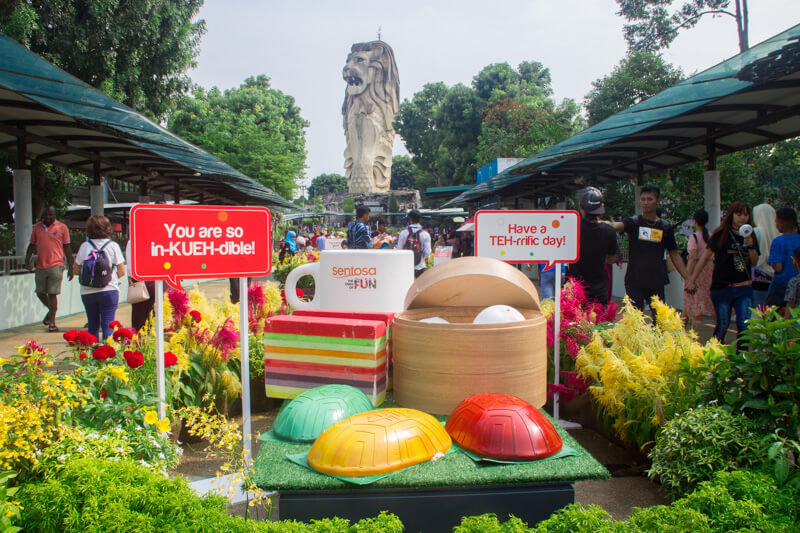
[17,459,403,533]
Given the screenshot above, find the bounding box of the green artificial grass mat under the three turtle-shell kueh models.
[253,394,611,491]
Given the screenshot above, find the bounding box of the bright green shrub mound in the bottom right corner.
[673,471,798,532]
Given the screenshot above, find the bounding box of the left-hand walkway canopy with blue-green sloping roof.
[0,30,297,209]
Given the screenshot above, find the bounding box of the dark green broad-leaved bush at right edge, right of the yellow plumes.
[706,308,800,439]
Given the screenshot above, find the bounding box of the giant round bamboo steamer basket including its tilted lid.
[392,257,547,415]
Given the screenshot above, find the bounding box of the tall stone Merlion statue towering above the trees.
[342,41,400,193]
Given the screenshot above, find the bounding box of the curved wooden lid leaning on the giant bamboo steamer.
[405,257,541,311]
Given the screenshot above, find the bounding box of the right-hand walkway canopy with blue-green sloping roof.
[445,24,800,206]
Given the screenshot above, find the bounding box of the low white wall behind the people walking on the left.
[0,273,220,330]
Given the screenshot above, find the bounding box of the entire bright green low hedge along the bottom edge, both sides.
[16,459,800,533]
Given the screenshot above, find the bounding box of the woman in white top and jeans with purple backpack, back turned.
[74,215,125,340]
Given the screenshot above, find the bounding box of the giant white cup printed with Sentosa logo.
[285,250,414,313]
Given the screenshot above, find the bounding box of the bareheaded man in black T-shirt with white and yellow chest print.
[610,185,689,310]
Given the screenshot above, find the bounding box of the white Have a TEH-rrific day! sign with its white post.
[475,211,581,428]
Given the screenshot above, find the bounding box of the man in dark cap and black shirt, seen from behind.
[568,187,617,305]
